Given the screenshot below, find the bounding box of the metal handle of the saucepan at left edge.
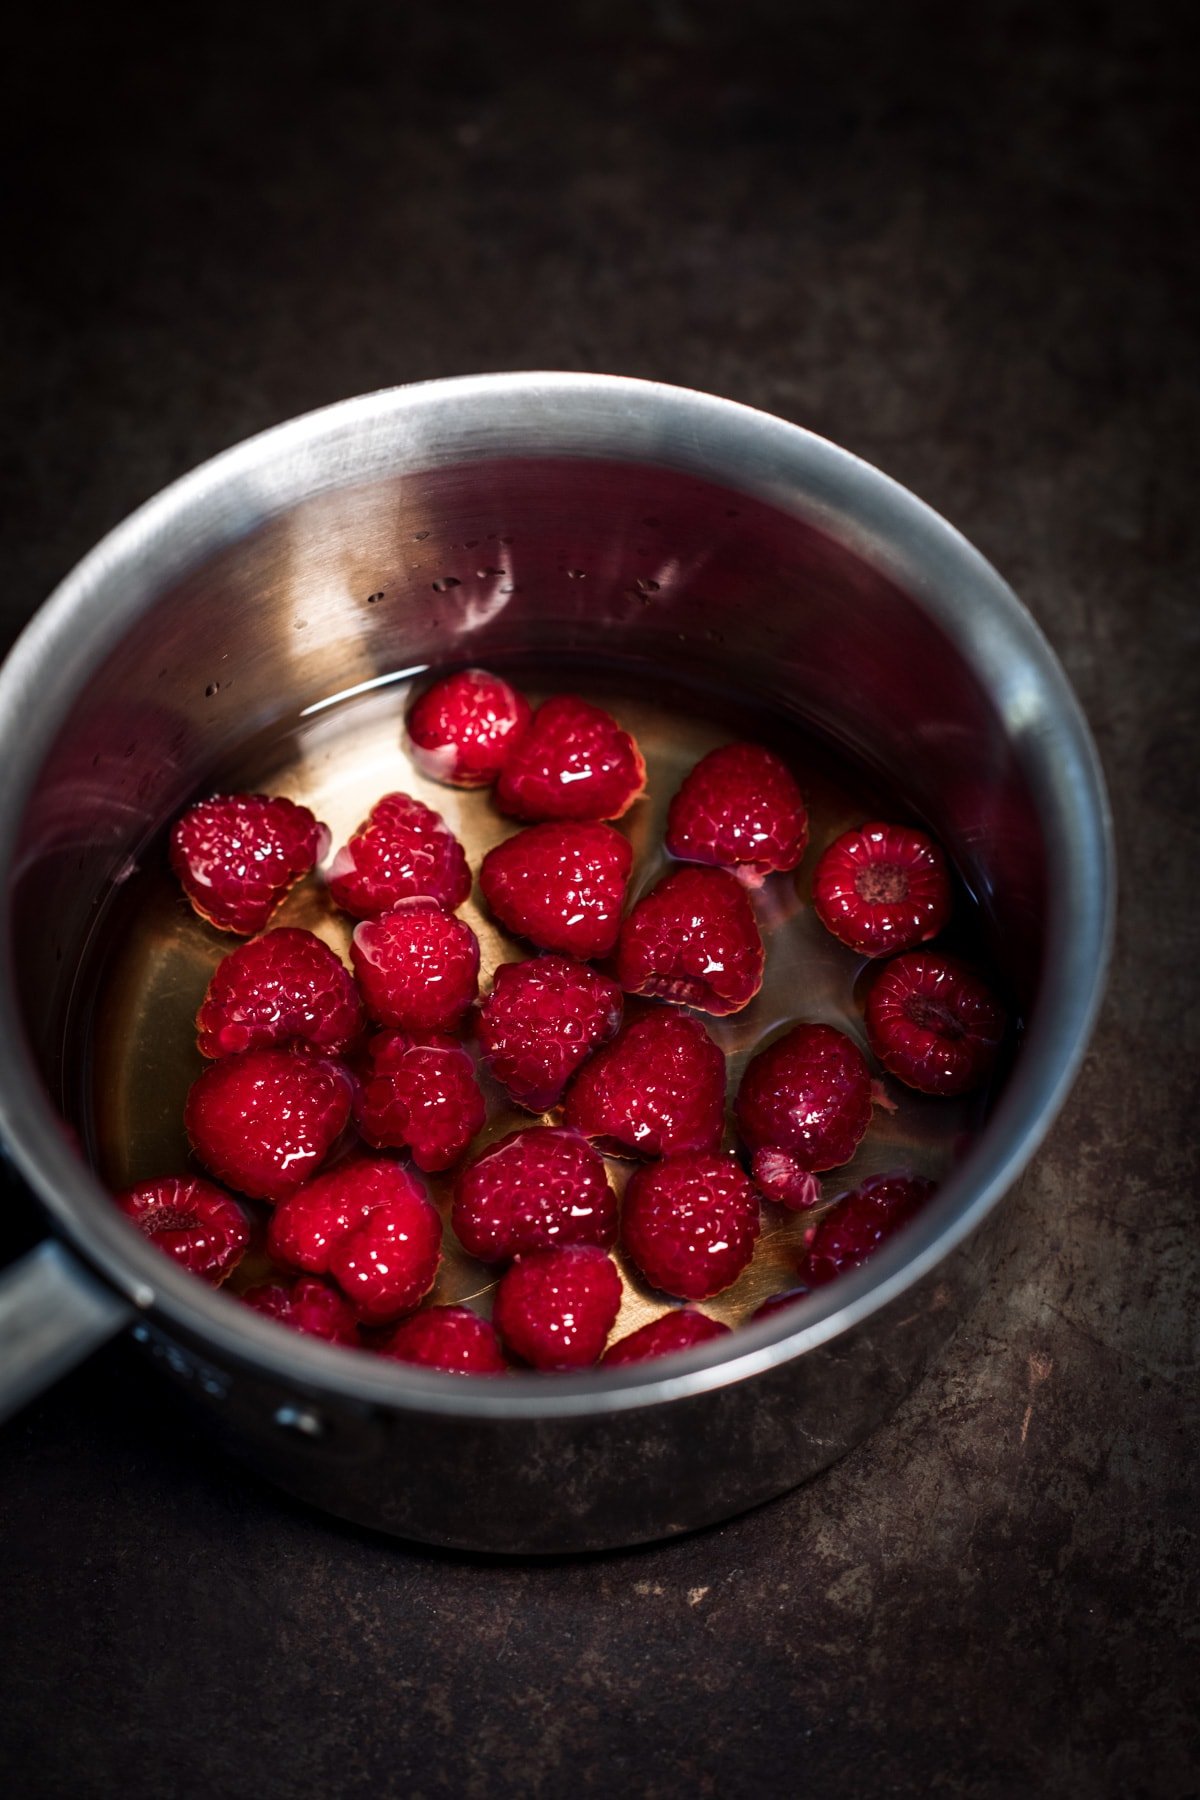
[0,1238,133,1424]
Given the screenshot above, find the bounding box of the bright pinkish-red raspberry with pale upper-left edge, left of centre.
[351,900,479,1031]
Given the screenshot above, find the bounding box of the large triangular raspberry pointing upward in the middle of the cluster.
[563,1012,725,1156]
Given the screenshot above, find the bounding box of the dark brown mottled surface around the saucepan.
[0,0,1200,1800]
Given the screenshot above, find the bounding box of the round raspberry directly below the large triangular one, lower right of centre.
[621,1156,761,1300]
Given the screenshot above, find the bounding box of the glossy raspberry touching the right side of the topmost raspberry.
[497,695,646,819]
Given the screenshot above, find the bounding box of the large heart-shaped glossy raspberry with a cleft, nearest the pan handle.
[266,1157,441,1325]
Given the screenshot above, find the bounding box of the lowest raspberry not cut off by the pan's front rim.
[493,1244,621,1370]
